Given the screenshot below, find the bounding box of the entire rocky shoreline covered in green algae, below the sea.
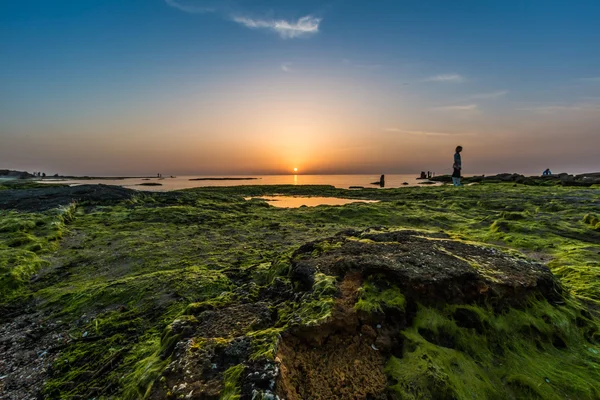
[0,183,600,400]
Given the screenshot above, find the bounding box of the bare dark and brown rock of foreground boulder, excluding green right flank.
[144,229,561,399]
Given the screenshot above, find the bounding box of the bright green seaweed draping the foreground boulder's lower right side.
[386,300,600,399]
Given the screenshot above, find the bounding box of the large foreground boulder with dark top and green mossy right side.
[139,229,600,400]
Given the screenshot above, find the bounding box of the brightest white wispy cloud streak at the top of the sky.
[164,0,322,39]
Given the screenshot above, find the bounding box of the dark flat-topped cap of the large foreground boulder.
[292,231,561,305]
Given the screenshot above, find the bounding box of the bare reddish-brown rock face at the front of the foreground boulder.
[276,273,390,400]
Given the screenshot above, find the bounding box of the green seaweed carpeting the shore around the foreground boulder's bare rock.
[0,183,600,399]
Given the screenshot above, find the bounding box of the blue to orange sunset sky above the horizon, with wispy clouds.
[0,0,600,176]
